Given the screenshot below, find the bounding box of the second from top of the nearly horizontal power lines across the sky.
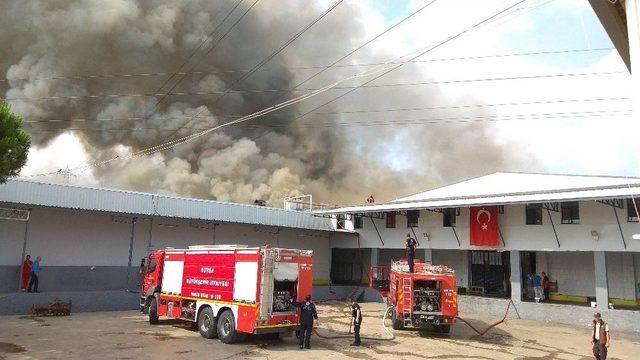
[0,71,628,101]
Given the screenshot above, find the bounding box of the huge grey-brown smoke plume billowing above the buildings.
[0,0,530,205]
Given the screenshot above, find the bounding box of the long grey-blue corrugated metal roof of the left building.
[0,179,336,231]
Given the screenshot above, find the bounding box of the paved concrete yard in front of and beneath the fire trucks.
[0,303,640,360]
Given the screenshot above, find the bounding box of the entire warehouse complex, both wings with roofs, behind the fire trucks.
[0,173,640,331]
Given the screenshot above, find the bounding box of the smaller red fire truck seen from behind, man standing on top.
[369,260,458,333]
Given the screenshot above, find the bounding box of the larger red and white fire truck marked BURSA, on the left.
[140,245,313,343]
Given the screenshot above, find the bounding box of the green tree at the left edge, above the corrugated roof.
[0,101,31,184]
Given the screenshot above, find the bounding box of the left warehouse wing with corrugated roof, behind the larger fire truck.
[0,180,353,292]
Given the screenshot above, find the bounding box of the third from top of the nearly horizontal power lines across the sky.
[23,97,631,124]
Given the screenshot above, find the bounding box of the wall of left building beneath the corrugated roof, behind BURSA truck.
[0,205,344,292]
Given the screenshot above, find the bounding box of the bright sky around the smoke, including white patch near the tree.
[11,0,640,202]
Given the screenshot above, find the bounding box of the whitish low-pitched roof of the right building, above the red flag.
[323,173,640,214]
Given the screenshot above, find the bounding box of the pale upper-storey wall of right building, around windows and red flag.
[351,201,640,252]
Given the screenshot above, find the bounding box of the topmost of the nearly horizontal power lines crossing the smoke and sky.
[0,47,615,83]
